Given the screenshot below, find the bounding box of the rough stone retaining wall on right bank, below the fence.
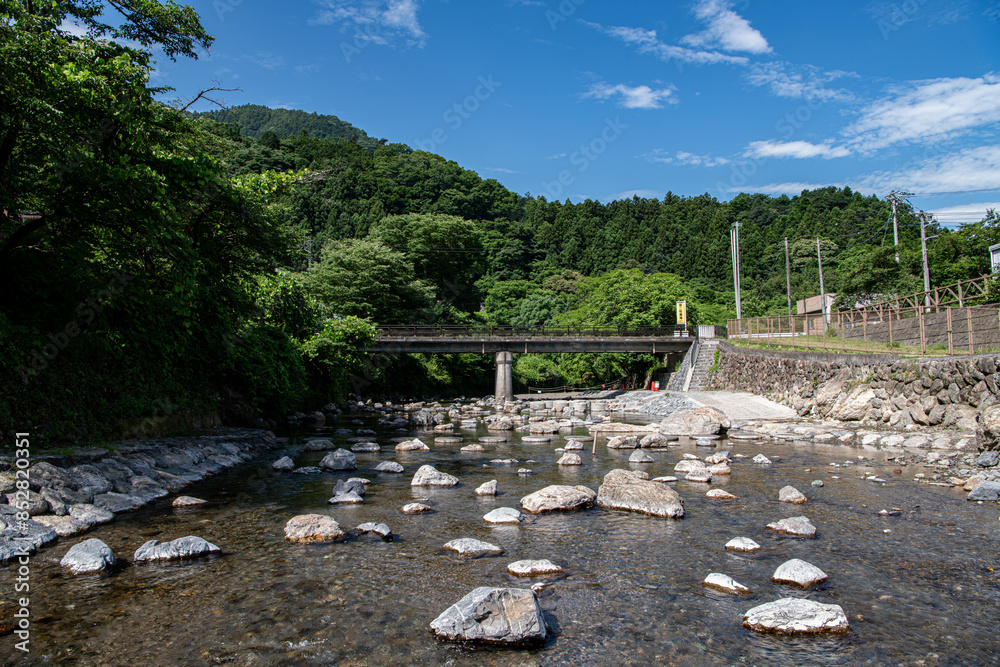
[708,342,1000,430]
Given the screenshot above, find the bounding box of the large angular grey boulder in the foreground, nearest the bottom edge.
[431,586,547,645]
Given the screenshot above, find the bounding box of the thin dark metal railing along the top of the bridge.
[376,324,698,338]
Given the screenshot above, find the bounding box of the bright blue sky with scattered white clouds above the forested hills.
[145,0,1000,225]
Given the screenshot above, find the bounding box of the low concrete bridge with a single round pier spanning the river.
[368,324,715,400]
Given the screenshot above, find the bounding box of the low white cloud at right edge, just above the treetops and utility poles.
[858,146,1000,194]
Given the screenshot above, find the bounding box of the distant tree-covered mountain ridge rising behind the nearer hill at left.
[193,104,379,147]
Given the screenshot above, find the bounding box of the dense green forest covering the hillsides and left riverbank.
[0,0,1000,444]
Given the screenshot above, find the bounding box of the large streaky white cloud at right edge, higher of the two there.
[845,74,1000,151]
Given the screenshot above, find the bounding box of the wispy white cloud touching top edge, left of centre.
[308,0,427,47]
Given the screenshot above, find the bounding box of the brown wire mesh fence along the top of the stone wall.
[727,304,1000,356]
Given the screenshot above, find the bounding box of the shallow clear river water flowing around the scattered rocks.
[7,410,1000,665]
